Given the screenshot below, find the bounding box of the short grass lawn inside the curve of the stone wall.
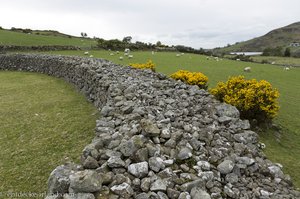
[0,71,98,194]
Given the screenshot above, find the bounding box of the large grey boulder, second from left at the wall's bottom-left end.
[70,170,102,193]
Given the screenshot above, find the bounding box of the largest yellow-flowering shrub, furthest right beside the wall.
[210,76,279,122]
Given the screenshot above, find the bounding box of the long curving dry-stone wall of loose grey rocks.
[0,54,300,199]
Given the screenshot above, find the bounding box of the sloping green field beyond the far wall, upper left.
[0,30,97,48]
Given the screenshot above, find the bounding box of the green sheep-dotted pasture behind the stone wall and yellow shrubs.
[42,51,300,187]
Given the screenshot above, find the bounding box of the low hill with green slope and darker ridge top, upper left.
[0,28,97,48]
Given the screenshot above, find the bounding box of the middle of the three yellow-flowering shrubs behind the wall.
[170,70,208,89]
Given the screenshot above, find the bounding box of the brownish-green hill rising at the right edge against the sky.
[214,22,300,53]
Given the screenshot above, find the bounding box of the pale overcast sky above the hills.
[0,0,300,48]
